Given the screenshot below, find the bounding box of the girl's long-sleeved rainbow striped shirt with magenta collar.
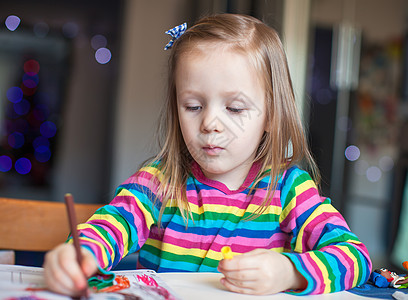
[78,163,371,294]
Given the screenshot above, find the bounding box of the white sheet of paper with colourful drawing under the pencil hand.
[0,265,180,300]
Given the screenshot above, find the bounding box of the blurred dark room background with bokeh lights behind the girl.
[0,0,408,270]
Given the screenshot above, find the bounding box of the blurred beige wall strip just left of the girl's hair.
[111,0,188,190]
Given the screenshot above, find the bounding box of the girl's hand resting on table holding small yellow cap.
[218,249,307,295]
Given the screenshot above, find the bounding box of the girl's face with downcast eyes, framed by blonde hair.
[176,43,266,190]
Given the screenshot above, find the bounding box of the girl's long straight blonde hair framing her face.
[147,14,320,223]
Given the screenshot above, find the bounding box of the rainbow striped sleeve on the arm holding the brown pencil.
[78,169,160,270]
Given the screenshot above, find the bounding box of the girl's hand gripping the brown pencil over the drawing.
[44,244,98,296]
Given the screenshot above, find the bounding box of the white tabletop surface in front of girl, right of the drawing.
[158,273,378,300]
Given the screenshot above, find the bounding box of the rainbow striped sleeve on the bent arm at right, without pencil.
[280,168,371,294]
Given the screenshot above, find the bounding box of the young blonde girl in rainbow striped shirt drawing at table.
[44,14,371,295]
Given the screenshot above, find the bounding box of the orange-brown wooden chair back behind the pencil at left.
[0,198,102,251]
